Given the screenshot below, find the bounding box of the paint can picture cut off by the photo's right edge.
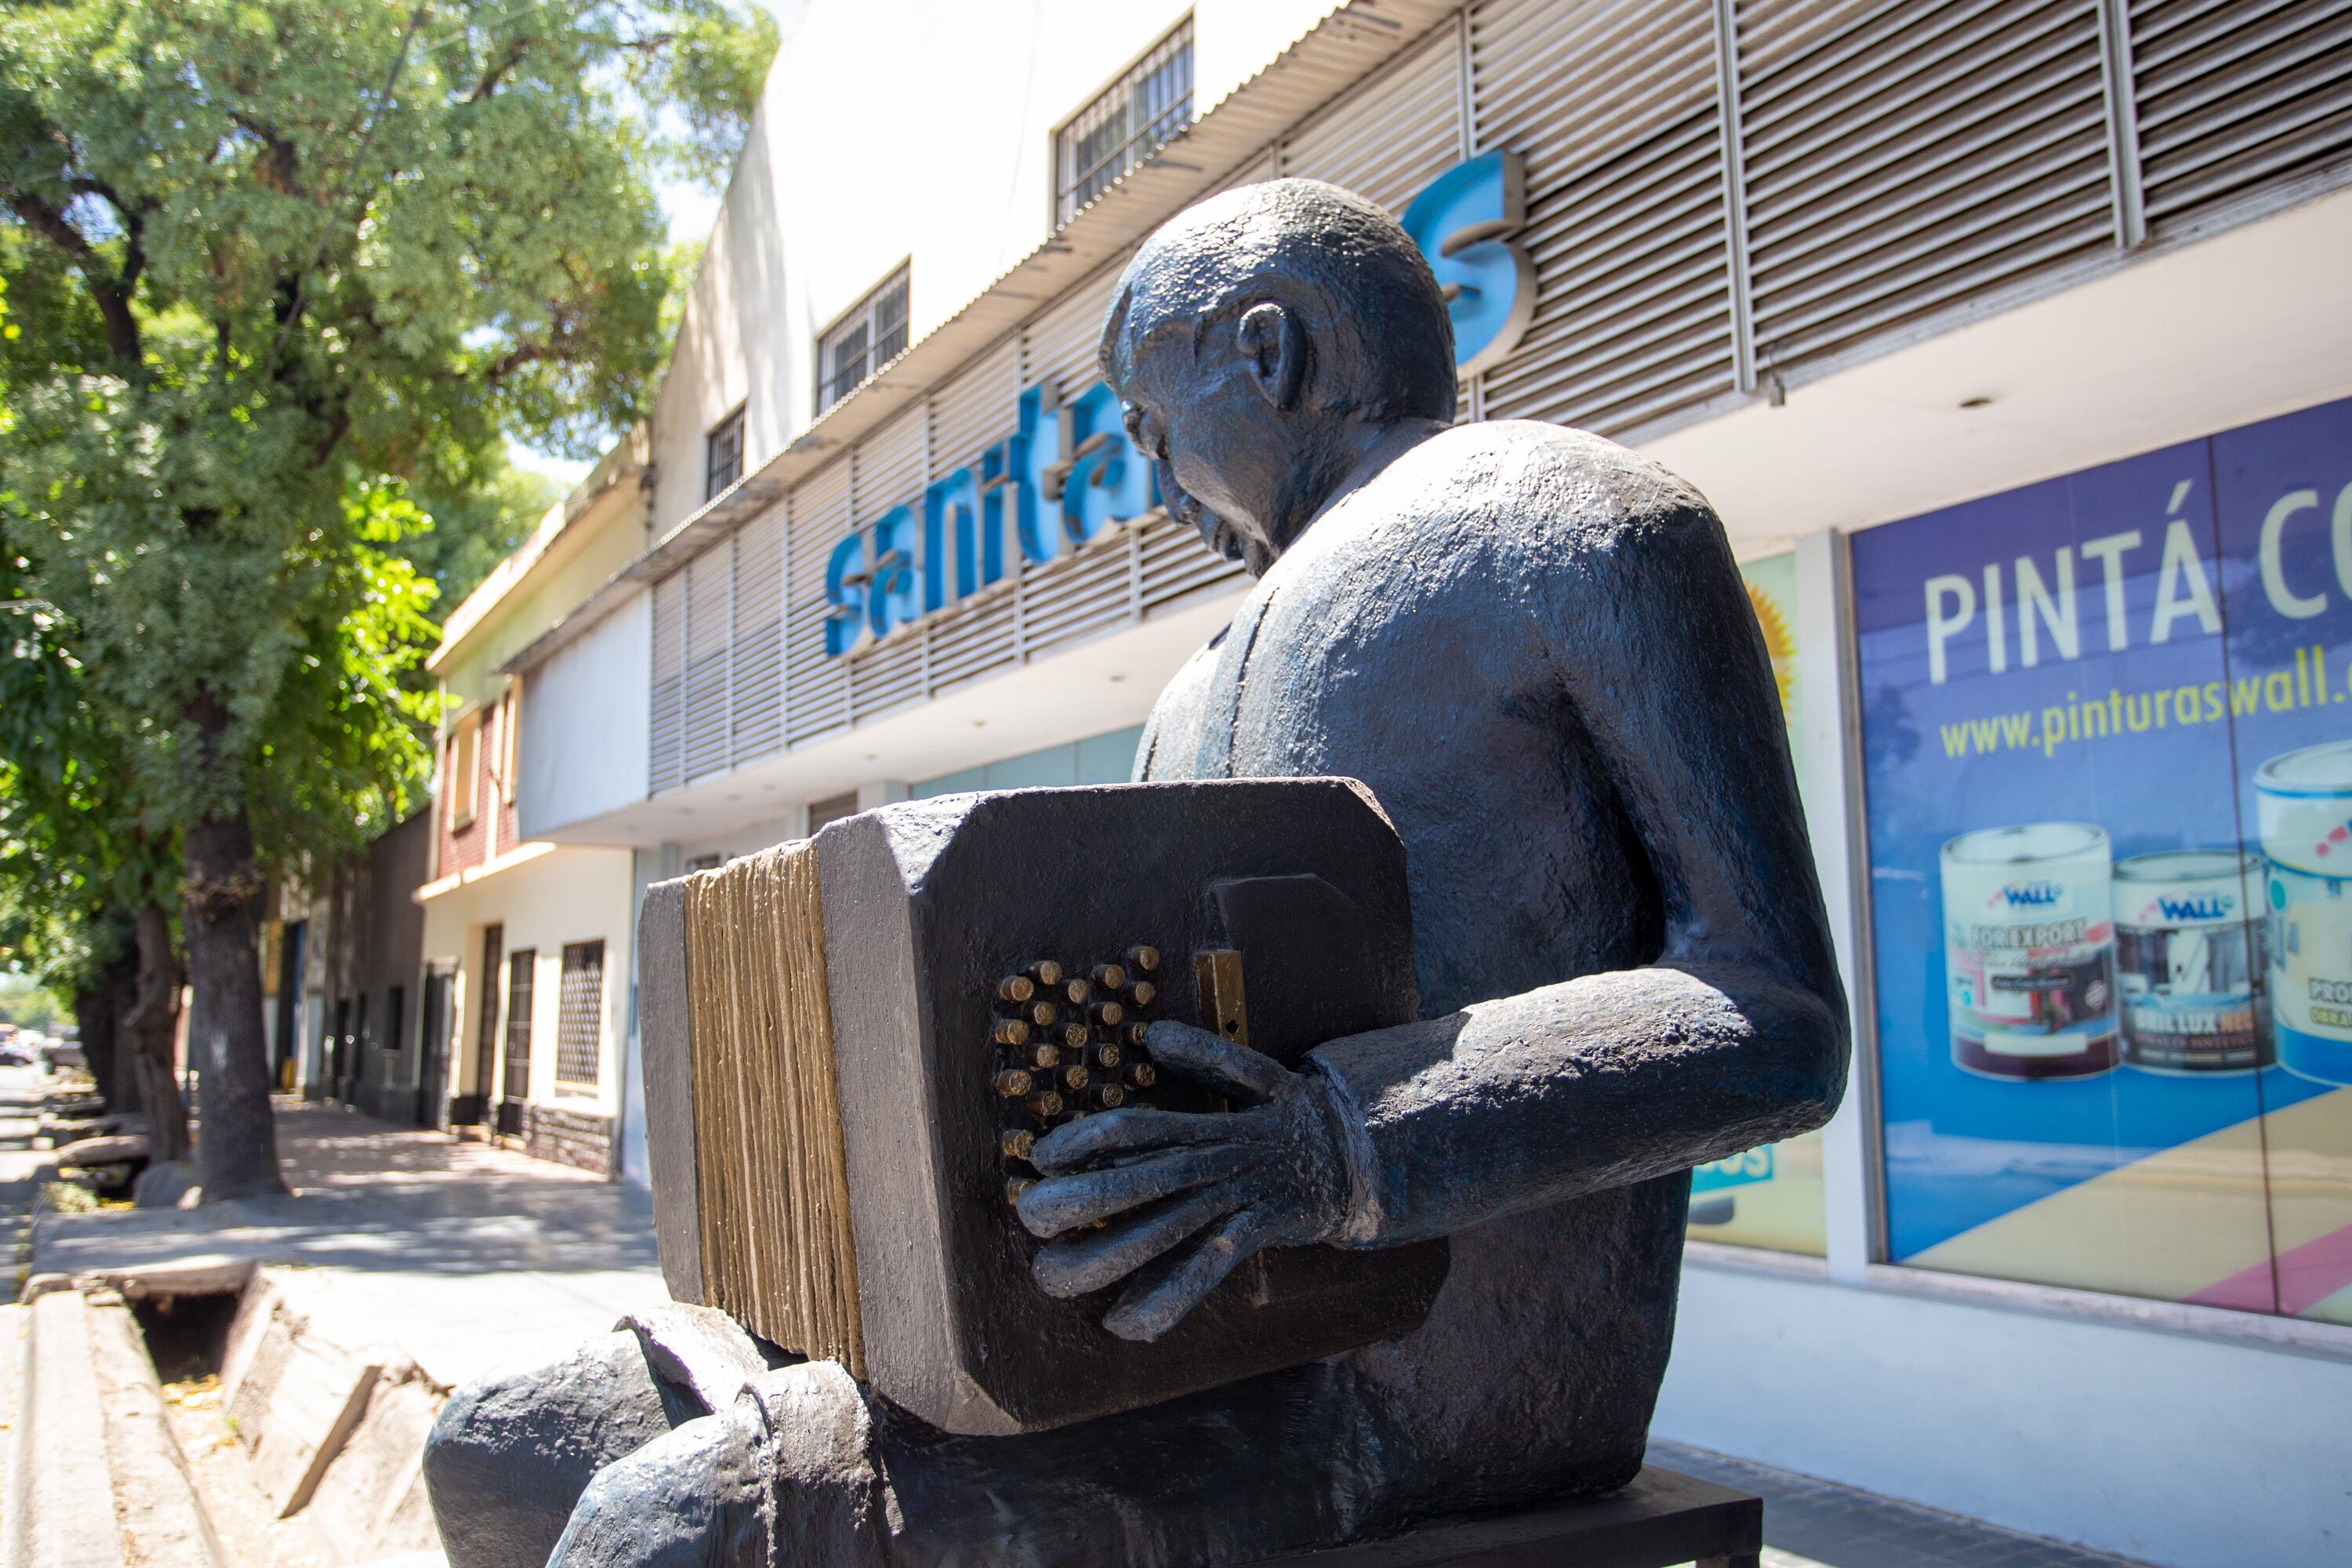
[2253,741,2352,1083]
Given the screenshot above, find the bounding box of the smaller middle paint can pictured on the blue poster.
[2114,848,2270,1072]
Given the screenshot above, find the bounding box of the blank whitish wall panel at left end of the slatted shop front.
[515,593,652,839]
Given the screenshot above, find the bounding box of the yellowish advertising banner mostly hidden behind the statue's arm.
[1689,553,1828,1258]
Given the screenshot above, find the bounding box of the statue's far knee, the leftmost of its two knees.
[423,1333,701,1568]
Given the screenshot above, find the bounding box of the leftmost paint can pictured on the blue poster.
[1940,822,2117,1079]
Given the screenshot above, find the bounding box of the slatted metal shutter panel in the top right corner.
[2131,0,2352,233]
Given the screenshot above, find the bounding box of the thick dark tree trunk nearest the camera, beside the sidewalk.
[181,804,287,1203]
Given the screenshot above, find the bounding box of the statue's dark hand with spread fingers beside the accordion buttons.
[1016,1020,1348,1340]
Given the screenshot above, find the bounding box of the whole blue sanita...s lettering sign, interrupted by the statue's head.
[826,153,1536,659]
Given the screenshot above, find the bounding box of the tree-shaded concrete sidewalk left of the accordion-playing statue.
[28,1100,668,1389]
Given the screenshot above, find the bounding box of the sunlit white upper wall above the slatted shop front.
[654,0,1336,536]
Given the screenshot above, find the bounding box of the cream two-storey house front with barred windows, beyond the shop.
[414,433,649,1173]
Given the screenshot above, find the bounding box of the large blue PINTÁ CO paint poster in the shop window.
[1853,402,2352,1321]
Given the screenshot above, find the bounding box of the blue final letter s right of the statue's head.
[1404,148,1536,376]
